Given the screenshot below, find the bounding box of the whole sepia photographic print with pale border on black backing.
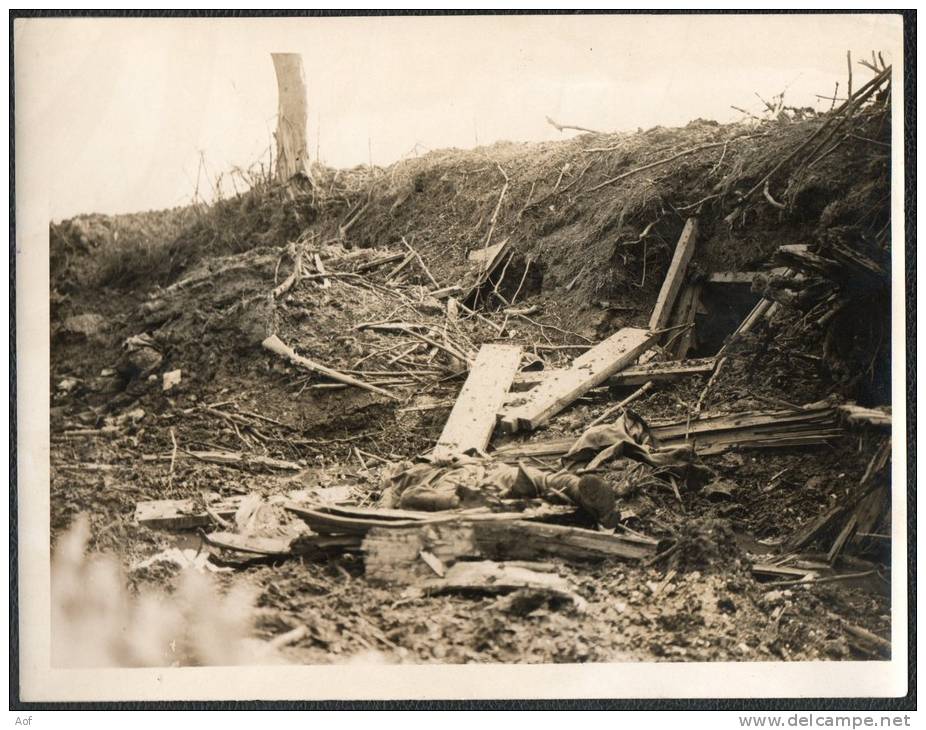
[10,12,915,702]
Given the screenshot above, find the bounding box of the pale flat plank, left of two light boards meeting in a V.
[433,345,521,460]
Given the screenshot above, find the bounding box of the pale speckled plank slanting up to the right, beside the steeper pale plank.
[501,327,656,433]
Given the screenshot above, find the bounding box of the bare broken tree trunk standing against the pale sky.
[270,53,308,183]
